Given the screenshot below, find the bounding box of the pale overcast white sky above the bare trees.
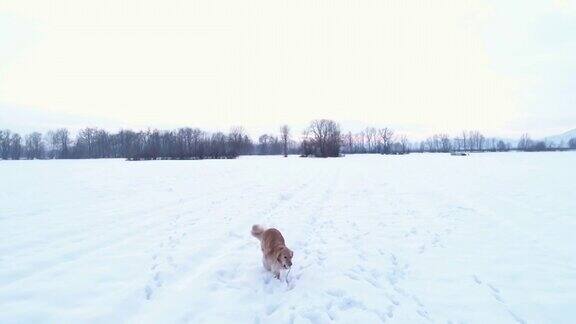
[0,0,576,137]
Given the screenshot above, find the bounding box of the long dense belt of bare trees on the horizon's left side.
[0,127,253,160]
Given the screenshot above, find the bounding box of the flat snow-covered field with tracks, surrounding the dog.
[0,152,576,323]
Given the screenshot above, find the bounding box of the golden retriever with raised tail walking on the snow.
[252,225,294,279]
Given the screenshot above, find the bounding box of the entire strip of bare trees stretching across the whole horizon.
[0,119,576,160]
